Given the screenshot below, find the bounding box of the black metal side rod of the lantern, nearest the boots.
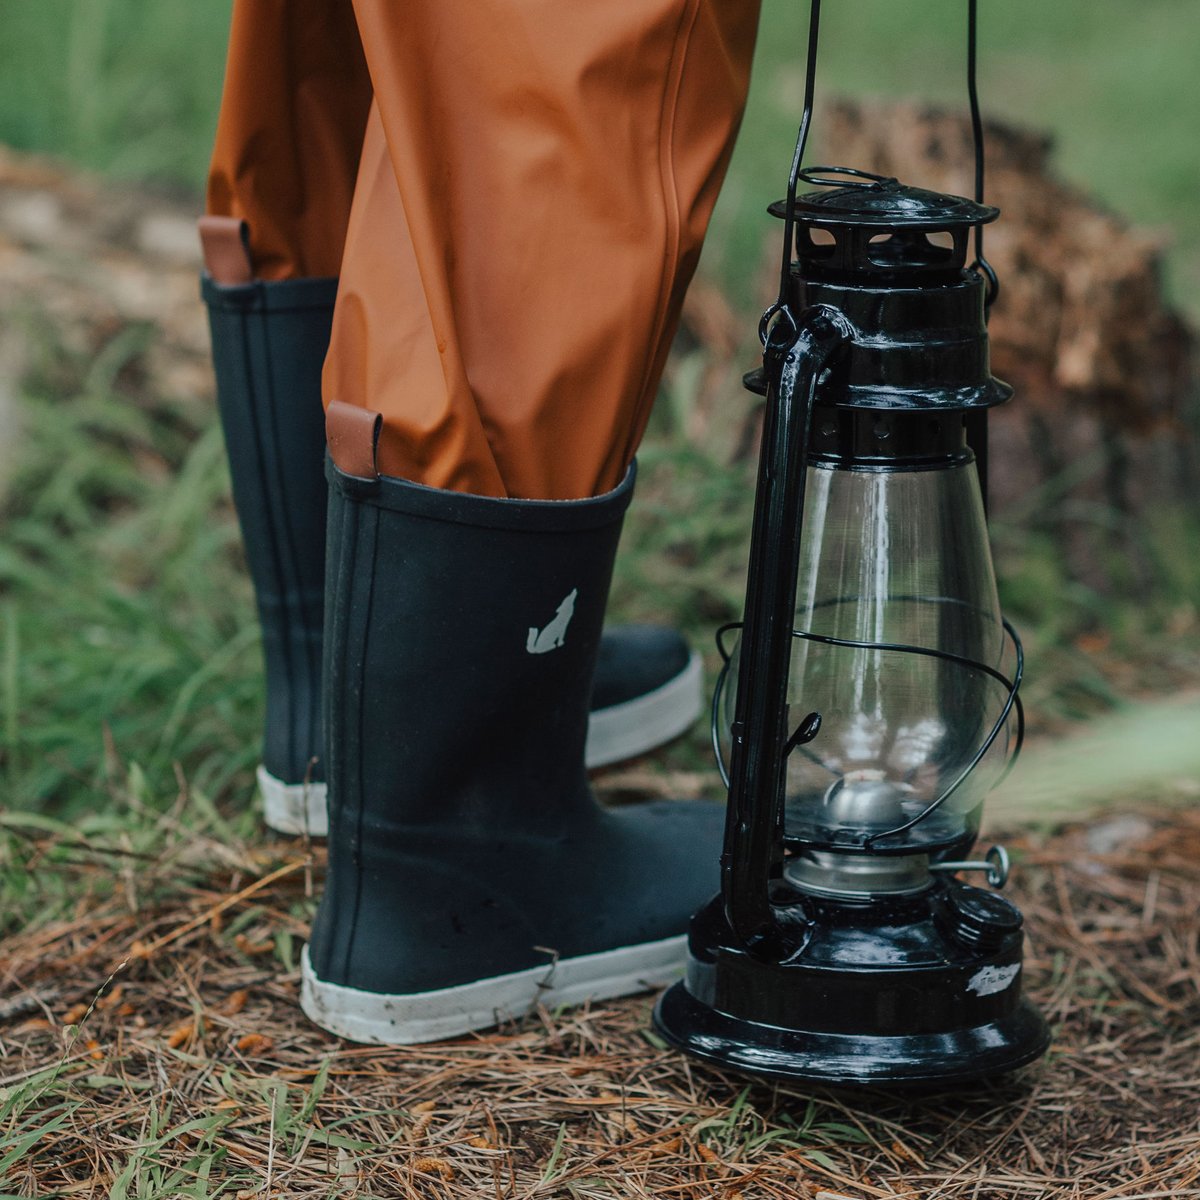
[721,305,854,948]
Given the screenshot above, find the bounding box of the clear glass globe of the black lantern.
[726,454,1010,848]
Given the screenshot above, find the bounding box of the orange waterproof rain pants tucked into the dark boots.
[208,0,758,499]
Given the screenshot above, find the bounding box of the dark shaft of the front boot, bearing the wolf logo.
[325,462,632,857]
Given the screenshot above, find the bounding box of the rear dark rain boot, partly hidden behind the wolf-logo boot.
[200,217,703,838]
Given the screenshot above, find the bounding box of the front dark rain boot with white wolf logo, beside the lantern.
[301,404,724,1044]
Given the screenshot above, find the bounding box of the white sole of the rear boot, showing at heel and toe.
[258,650,704,838]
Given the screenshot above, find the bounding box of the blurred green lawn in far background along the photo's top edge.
[0,0,1200,314]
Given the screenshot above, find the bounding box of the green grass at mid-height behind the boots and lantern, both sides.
[0,304,1200,816]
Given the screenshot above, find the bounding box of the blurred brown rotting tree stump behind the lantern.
[821,101,1200,592]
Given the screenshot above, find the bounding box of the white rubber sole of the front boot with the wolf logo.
[300,936,688,1045]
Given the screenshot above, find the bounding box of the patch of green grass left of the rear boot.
[0,314,262,811]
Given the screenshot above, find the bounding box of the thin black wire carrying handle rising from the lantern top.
[758,0,1000,350]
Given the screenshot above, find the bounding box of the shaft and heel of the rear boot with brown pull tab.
[200,217,337,833]
